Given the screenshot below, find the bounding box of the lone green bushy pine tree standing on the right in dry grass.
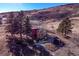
[57,18,72,36]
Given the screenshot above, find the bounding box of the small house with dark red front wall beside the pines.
[32,26,47,39]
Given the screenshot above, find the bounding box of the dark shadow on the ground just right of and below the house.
[37,34,65,48]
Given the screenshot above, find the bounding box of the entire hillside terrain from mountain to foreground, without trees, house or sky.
[0,3,79,56]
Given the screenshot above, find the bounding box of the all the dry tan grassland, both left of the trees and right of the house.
[0,17,79,56]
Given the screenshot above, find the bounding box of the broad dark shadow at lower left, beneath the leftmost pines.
[7,37,35,56]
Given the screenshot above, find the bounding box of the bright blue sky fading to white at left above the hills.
[0,3,64,13]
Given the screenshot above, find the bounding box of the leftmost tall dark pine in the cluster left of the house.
[6,12,19,37]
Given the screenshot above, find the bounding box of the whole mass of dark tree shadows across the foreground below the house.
[7,37,50,56]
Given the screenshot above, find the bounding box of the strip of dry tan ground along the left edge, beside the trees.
[0,25,10,56]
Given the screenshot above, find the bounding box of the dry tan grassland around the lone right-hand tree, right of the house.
[41,17,79,56]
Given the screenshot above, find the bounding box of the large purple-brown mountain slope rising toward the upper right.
[29,4,79,20]
